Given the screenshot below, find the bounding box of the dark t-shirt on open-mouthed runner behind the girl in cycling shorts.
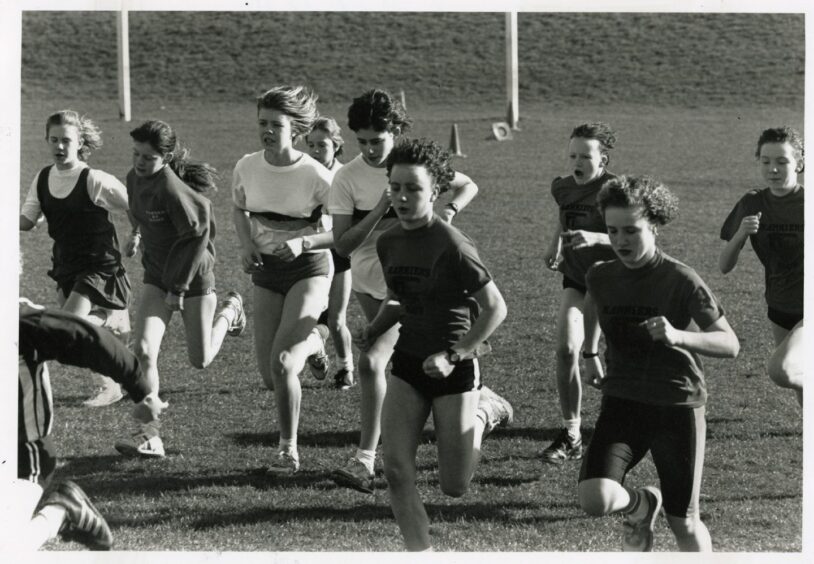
[551,172,616,286]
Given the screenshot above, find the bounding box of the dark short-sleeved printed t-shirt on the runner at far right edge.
[721,186,805,315]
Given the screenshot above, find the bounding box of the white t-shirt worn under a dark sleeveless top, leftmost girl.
[20,161,128,223]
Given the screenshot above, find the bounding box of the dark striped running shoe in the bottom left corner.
[40,480,113,550]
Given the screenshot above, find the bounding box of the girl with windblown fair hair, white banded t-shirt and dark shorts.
[232,86,333,472]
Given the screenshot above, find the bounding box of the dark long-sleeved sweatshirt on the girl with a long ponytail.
[127,166,215,293]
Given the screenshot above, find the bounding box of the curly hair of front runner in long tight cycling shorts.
[596,175,678,225]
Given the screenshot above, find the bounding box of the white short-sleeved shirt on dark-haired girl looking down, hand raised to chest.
[328,155,398,300]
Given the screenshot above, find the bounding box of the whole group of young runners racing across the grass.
[20,90,804,551]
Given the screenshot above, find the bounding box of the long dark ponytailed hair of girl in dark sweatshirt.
[130,119,218,192]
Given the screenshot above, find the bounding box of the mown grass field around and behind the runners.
[12,9,803,552]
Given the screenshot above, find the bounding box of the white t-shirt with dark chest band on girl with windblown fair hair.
[232,151,332,254]
